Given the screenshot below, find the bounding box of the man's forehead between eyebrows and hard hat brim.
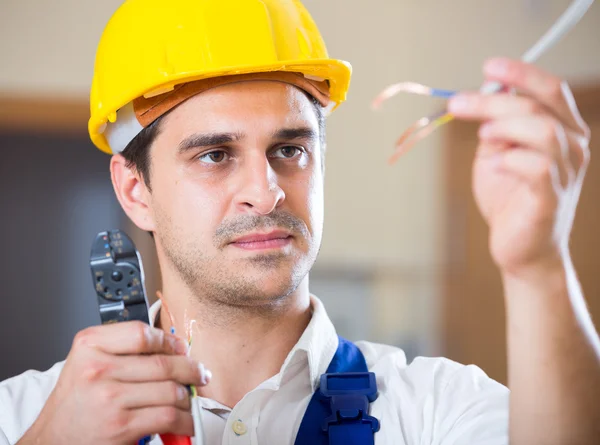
[163,81,318,131]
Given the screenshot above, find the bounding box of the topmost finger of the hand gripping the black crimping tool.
[73,321,187,355]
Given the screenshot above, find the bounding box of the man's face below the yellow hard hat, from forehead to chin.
[148,81,323,306]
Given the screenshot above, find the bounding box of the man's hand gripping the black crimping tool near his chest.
[19,322,207,445]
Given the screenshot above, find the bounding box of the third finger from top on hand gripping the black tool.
[116,382,190,411]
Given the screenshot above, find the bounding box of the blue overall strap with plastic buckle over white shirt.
[295,337,379,445]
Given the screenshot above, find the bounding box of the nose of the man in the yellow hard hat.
[236,155,285,215]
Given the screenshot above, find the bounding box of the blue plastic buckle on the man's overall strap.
[320,372,380,433]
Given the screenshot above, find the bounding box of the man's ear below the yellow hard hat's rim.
[110,154,154,232]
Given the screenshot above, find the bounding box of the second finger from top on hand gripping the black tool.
[106,354,212,386]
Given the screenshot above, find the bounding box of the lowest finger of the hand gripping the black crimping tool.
[128,406,194,437]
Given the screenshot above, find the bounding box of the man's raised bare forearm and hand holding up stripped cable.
[449,59,600,445]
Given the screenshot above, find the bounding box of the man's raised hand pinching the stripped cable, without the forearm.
[449,55,590,278]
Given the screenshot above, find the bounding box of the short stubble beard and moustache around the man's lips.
[155,205,320,324]
